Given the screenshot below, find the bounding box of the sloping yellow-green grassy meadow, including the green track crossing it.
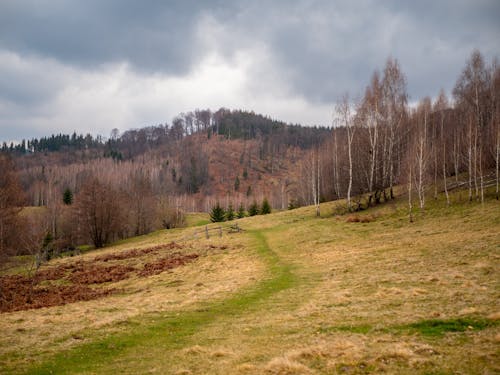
[0,192,500,374]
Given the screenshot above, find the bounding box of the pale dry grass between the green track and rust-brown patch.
[0,234,264,367]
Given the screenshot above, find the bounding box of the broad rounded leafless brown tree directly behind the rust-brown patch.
[75,177,125,248]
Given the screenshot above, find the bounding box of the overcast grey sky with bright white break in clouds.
[0,0,500,141]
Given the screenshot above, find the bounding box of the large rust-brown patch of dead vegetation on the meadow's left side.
[0,242,199,312]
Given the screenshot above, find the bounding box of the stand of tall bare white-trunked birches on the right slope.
[294,51,500,214]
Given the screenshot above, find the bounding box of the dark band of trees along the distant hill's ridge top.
[1,108,330,160]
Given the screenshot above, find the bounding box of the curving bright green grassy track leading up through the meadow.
[22,230,298,374]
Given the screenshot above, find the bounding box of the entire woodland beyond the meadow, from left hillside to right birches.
[0,50,500,257]
